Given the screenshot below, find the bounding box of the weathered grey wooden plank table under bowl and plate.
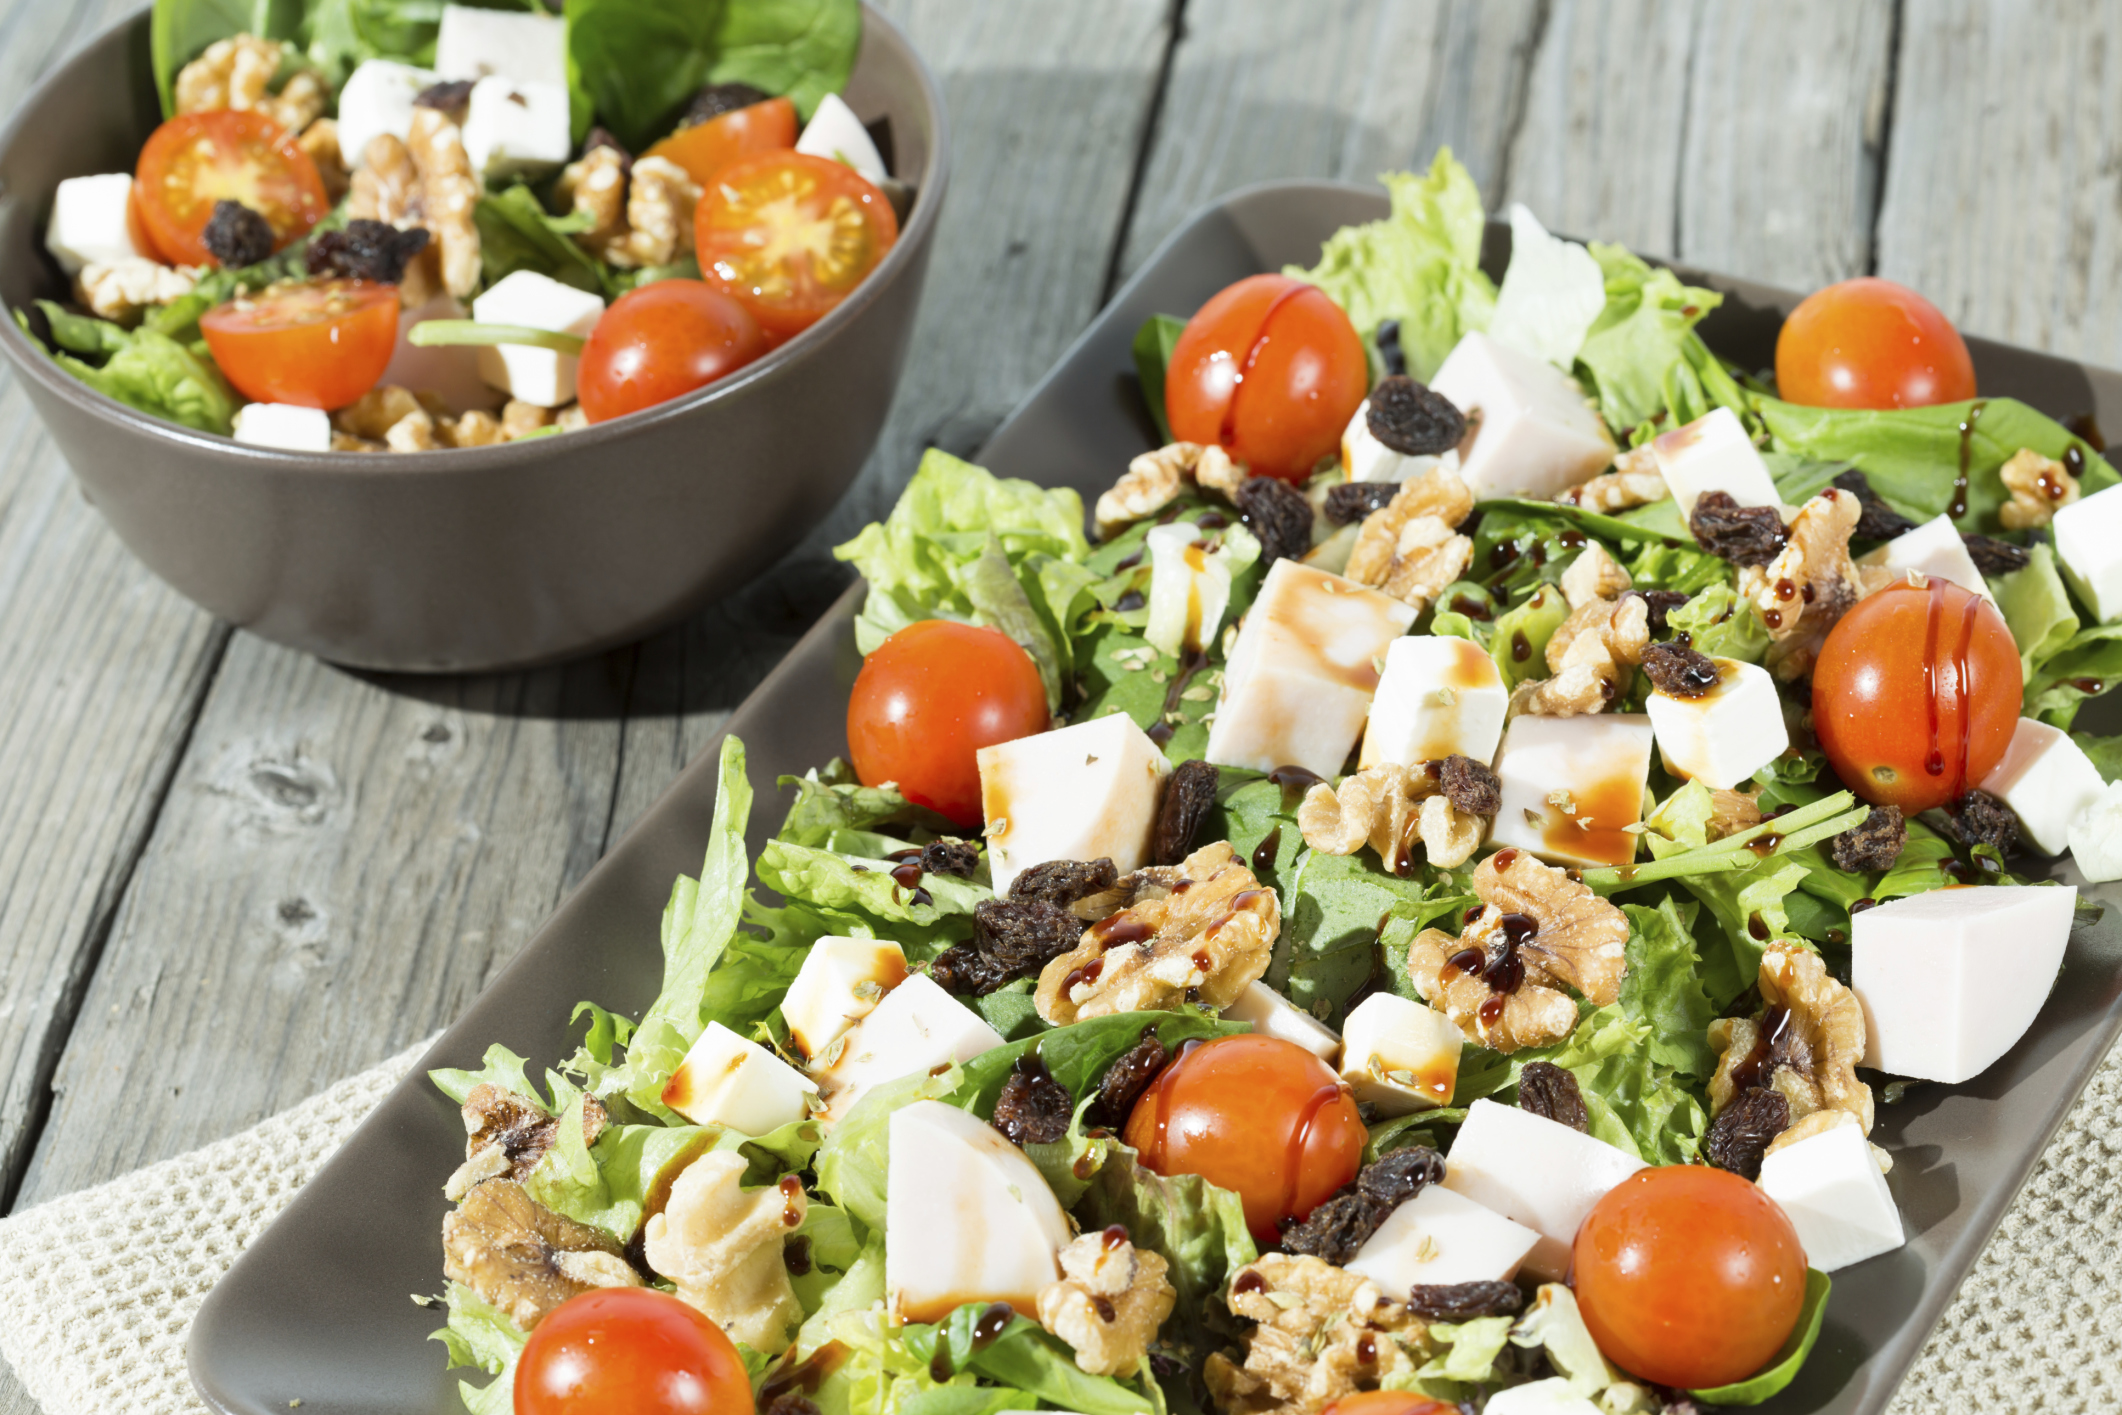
[0,0,2122,1415]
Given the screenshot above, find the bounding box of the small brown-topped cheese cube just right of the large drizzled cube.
[1358,634,1511,766]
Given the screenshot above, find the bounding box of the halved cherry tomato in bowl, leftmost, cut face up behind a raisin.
[134,108,331,265]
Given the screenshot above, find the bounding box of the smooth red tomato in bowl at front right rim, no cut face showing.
[575,280,766,422]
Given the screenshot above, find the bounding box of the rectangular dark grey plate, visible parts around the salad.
[191,182,2122,1415]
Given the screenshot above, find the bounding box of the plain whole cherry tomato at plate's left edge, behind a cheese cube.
[847,619,1050,829]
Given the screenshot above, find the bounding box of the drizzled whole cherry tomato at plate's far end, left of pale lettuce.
[1165,276,1371,482]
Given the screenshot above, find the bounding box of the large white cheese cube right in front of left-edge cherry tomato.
[978,713,1171,897]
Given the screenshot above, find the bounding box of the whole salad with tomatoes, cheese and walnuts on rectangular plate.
[427,153,2122,1415]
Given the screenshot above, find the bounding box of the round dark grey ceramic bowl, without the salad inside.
[0,6,949,672]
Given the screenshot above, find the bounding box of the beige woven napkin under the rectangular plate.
[0,1042,2122,1415]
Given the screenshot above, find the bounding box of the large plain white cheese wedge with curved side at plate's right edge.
[1850,885,2077,1084]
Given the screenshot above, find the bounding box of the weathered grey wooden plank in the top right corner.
[1878,0,2122,365]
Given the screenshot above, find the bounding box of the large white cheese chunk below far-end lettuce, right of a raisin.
[1430,333,1615,501]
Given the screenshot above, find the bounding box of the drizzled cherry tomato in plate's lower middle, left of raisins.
[1123,1035,1369,1243]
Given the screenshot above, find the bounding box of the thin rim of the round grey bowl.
[0,0,951,477]
